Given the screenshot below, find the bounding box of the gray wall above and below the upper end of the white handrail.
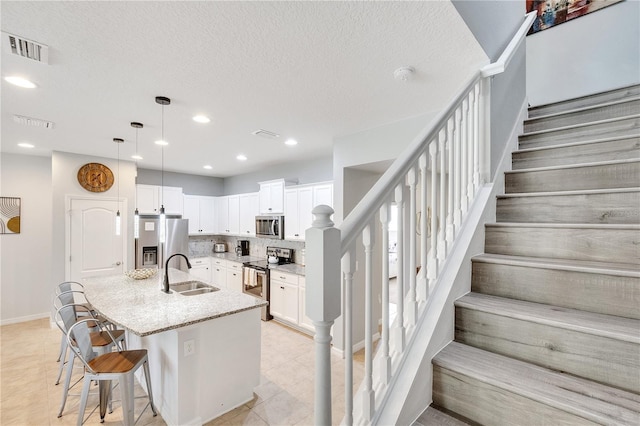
[452,0,527,180]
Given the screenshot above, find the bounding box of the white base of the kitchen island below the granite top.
[127,308,261,425]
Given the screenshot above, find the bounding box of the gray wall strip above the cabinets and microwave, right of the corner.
[224,156,333,195]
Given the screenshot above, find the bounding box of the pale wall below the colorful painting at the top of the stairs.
[527,0,640,105]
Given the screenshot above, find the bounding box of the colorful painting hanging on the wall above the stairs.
[526,0,624,35]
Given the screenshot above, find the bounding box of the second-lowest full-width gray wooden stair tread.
[455,293,640,344]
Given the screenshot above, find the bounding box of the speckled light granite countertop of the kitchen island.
[82,270,267,336]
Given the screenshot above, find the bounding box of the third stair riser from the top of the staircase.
[518,117,640,149]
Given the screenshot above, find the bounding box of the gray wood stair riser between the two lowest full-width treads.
[455,307,640,392]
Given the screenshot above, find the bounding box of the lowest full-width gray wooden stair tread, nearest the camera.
[433,342,640,424]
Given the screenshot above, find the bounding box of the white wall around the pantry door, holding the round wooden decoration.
[50,152,136,283]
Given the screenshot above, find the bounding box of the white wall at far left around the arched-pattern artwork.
[0,153,54,324]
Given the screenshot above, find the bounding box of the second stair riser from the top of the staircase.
[524,99,640,133]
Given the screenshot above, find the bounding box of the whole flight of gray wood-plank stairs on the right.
[416,86,640,425]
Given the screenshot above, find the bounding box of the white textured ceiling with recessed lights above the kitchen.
[0,1,487,177]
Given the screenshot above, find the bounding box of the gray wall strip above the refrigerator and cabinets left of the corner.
[136,169,224,196]
